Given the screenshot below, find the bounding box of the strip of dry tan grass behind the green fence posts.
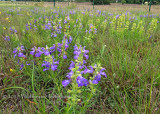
[0,2,160,14]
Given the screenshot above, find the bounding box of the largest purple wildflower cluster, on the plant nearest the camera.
[62,45,107,87]
